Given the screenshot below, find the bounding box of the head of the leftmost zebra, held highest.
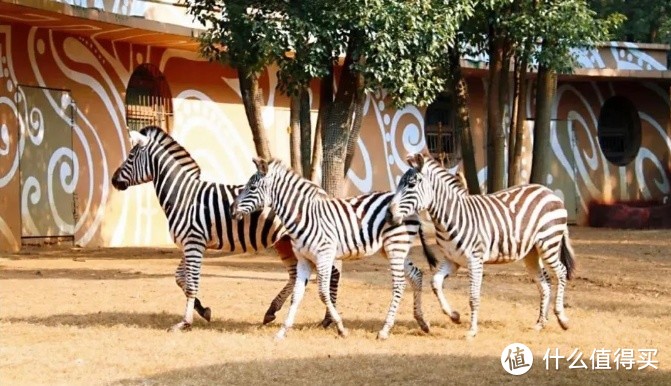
[112,131,153,190]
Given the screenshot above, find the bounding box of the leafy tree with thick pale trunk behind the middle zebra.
[189,0,472,196]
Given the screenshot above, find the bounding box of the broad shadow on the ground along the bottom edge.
[107,347,671,385]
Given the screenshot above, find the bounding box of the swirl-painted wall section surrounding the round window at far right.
[548,82,671,222]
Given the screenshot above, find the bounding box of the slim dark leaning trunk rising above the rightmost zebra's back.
[449,44,480,194]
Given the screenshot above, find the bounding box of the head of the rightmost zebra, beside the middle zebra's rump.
[387,153,433,225]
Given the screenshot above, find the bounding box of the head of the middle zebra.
[231,158,270,220]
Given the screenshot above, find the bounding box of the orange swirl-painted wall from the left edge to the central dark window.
[0,21,424,250]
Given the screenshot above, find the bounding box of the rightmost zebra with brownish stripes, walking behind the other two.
[388,154,575,338]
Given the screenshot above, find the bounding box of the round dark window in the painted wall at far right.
[597,96,641,166]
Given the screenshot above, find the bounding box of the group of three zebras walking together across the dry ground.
[112,126,575,339]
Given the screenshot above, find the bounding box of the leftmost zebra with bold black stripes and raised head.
[112,126,340,331]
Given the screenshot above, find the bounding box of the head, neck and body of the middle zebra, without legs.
[237,160,419,256]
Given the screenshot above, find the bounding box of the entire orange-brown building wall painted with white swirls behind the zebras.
[0,23,671,250]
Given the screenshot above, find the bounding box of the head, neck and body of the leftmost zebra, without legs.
[113,126,286,252]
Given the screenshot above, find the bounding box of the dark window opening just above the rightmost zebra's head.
[424,93,461,167]
